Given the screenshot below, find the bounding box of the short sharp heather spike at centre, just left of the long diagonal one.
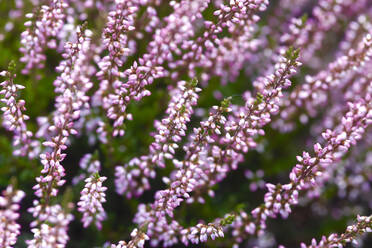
[115,80,201,198]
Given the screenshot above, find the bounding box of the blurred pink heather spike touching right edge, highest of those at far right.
[274,34,372,131]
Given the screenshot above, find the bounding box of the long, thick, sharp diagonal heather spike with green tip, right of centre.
[155,49,300,214]
